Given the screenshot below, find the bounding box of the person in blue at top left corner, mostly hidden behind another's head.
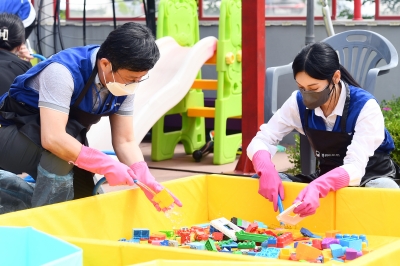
[0,0,36,61]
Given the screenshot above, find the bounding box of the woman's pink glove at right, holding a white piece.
[293,167,350,217]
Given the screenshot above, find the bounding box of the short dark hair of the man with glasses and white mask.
[97,22,160,72]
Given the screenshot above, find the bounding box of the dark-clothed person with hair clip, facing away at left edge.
[0,13,32,95]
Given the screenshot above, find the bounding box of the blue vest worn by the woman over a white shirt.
[297,85,394,154]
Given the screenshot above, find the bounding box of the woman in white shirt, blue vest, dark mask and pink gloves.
[247,42,399,217]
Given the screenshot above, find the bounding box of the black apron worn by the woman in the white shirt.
[289,84,400,186]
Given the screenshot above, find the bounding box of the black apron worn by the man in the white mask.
[0,65,110,199]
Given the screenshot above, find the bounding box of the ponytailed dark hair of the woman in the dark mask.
[292,42,361,88]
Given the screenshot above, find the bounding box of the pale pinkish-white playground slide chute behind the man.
[87,37,218,150]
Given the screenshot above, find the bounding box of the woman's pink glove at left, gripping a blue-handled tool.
[252,150,285,211]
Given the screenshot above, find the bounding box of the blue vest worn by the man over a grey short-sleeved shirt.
[0,45,126,125]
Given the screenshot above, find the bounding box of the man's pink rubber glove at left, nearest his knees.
[74,145,136,186]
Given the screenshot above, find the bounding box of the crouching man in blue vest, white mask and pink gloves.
[0,22,182,213]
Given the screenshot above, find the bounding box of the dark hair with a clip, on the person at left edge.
[0,13,25,51]
